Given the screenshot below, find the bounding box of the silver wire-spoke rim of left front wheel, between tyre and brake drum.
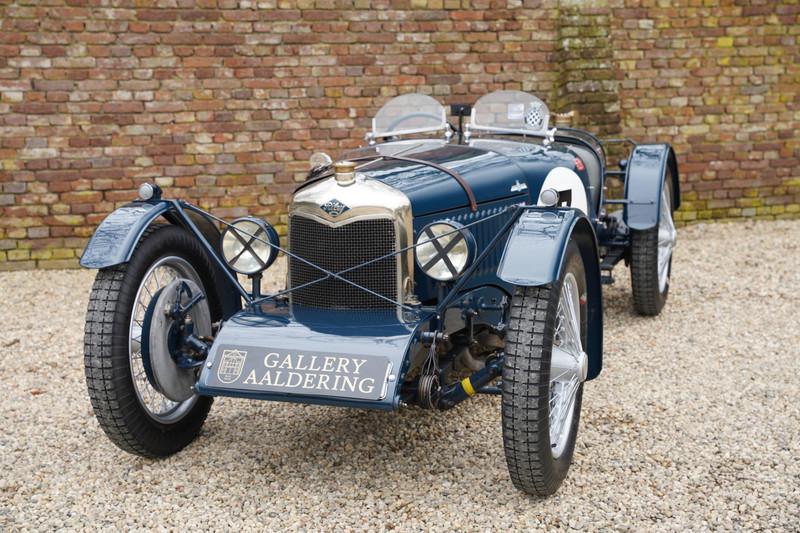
[129,256,201,424]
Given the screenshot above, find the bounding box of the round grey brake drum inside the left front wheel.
[142,278,212,402]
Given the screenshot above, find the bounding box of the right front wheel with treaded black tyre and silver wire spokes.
[502,242,588,496]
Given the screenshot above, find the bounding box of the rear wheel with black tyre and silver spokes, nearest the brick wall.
[631,170,677,316]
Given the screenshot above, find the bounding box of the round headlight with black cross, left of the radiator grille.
[222,217,280,276]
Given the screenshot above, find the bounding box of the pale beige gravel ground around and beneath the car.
[0,221,800,531]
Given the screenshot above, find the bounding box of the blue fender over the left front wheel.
[81,200,170,268]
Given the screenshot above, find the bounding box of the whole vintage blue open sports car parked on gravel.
[81,91,680,495]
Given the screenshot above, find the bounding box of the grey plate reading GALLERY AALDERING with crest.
[208,346,392,400]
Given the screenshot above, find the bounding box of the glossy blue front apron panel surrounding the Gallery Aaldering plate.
[197,304,430,409]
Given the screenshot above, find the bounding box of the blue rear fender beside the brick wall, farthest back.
[623,144,680,230]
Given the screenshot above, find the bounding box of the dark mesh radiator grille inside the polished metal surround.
[289,214,399,310]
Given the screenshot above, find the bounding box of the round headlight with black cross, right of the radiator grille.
[415,221,475,281]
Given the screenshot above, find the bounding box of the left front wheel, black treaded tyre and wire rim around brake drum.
[84,225,213,457]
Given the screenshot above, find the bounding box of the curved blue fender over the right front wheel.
[497,208,603,379]
